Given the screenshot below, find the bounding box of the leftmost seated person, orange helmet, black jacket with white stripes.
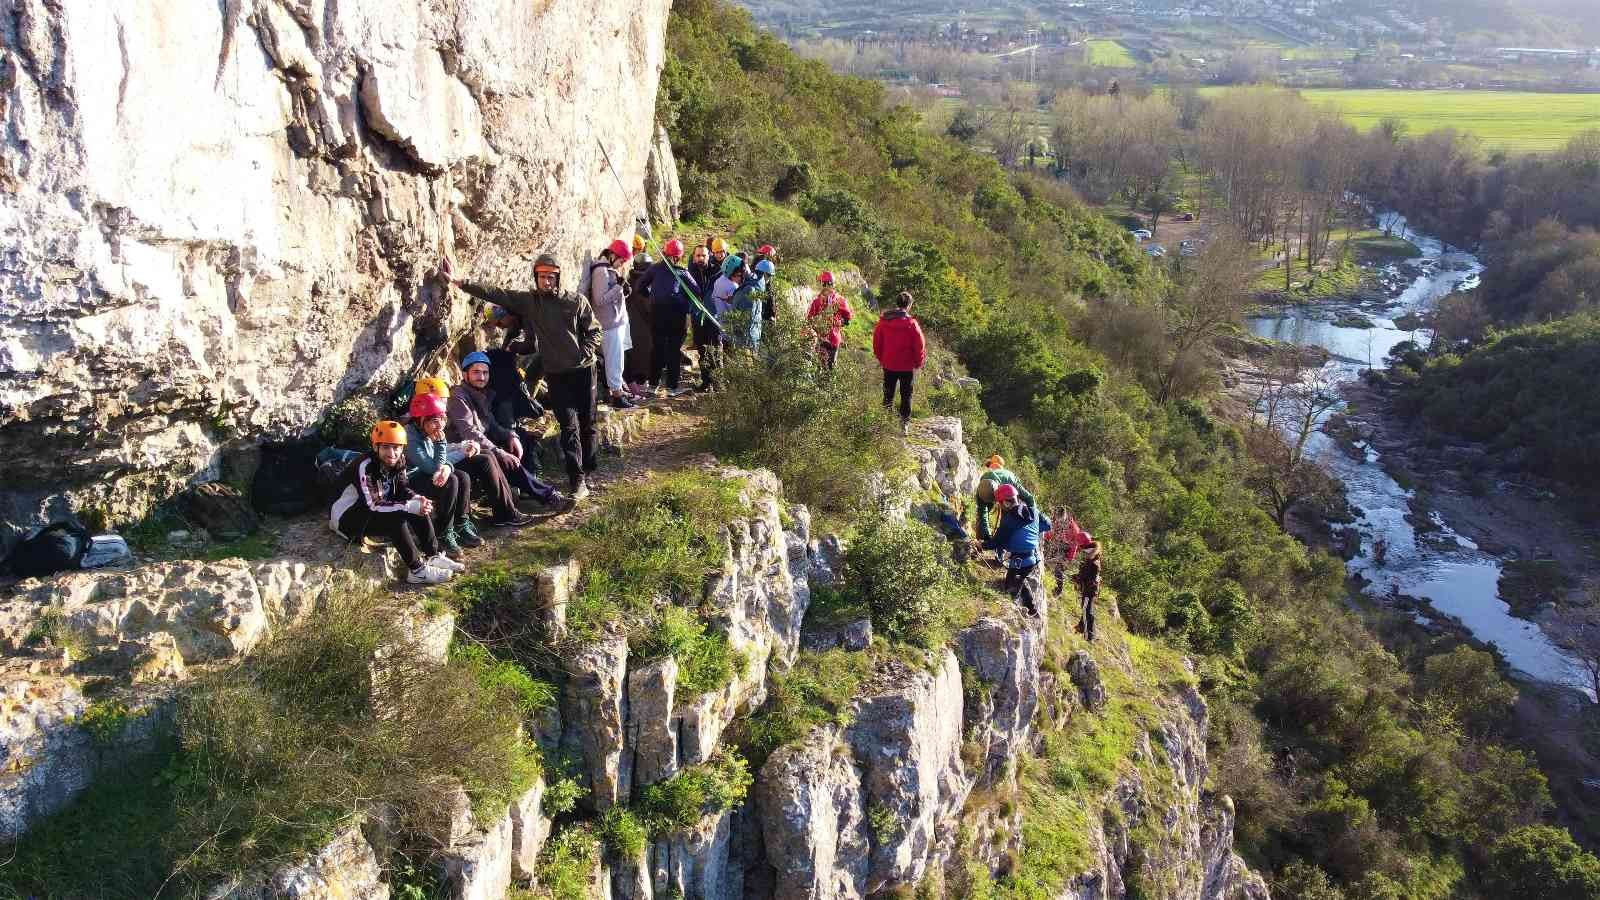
[328,421,466,585]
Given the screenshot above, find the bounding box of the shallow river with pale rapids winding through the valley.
[1250,216,1589,693]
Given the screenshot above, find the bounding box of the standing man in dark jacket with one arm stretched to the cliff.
[443,253,602,503]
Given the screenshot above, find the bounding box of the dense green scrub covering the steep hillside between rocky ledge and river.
[659,0,1600,900]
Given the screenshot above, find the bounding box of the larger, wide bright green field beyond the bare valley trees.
[1301,90,1600,152]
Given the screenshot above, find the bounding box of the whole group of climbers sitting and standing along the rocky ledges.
[330,230,1099,627]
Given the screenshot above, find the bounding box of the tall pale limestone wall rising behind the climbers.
[0,0,675,543]
